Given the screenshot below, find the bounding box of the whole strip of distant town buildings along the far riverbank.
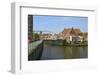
[40,27,87,43]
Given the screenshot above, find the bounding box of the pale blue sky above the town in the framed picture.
[33,15,88,33]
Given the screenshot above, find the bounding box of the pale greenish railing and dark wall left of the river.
[28,40,43,60]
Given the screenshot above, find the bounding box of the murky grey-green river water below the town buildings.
[41,45,88,60]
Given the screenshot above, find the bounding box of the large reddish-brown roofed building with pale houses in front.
[62,27,87,42]
